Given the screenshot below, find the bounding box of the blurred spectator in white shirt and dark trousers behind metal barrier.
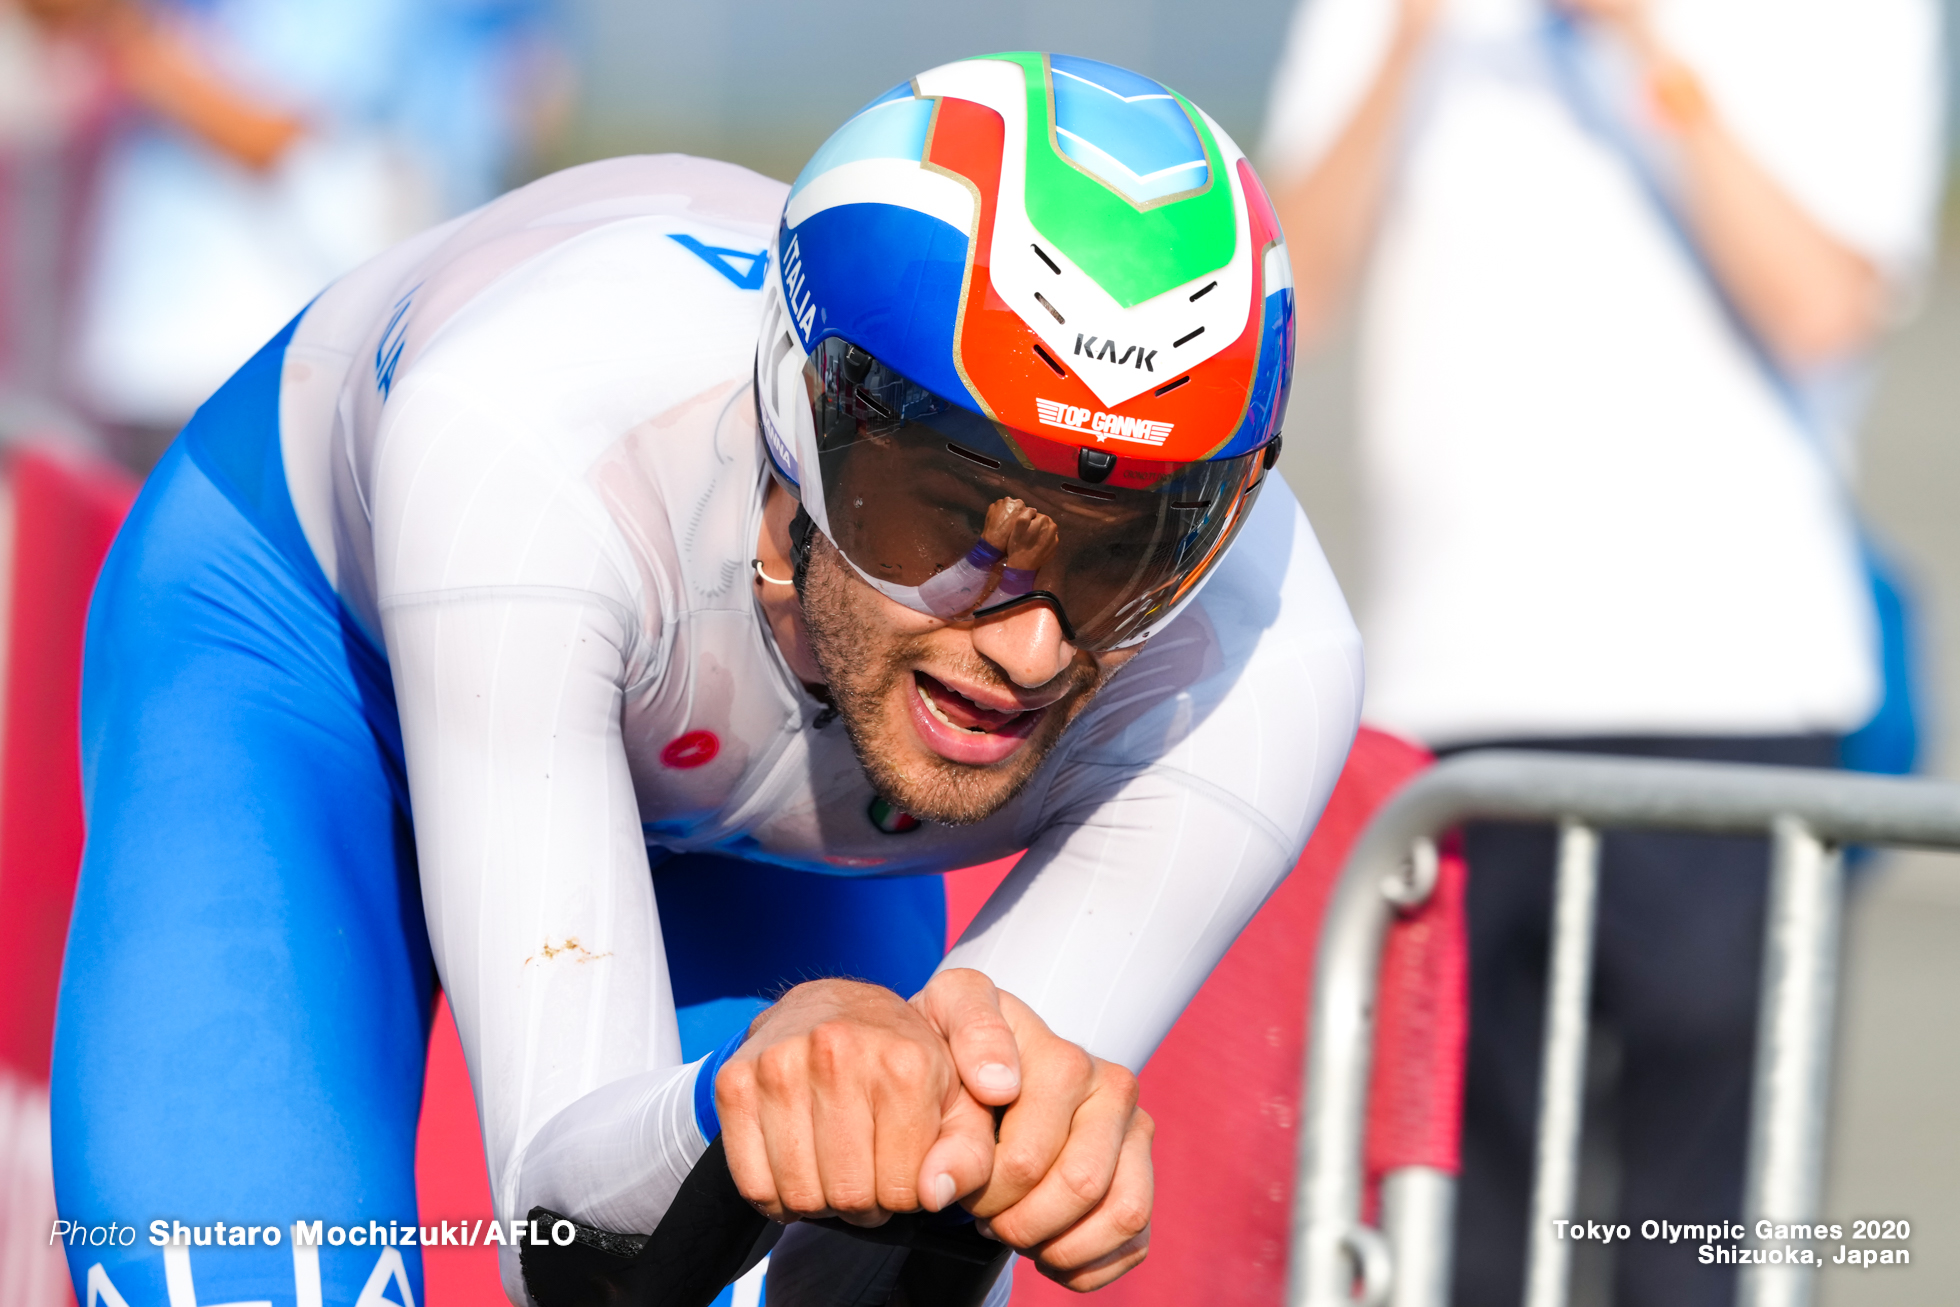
[1266,0,1942,1307]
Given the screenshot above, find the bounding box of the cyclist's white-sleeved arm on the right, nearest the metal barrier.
[943,482,1362,1070]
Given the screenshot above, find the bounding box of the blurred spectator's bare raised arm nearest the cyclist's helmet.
[1276,14,1429,347]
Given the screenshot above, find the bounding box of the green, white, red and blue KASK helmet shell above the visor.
[757,53,1294,639]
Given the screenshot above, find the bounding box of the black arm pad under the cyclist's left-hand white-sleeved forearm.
[519,1137,768,1307]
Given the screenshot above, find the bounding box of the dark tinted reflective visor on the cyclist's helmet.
[804,337,1264,651]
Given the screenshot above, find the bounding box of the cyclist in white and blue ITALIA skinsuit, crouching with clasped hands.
[53,53,1360,1307]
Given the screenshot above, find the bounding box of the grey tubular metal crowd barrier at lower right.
[1286,750,1960,1307]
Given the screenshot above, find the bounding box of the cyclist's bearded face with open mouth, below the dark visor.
[802,535,1133,825]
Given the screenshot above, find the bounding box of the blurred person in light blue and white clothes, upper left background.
[33,0,570,466]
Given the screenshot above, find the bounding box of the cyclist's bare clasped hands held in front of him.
[715,970,1152,1289]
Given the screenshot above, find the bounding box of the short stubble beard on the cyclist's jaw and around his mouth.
[796,533,1105,825]
